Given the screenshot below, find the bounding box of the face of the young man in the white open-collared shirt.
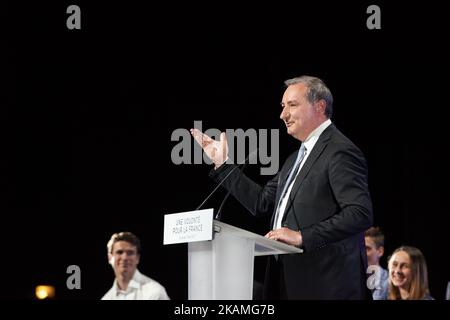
[112,241,139,277]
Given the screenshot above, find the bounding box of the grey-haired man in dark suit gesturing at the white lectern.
[191,76,373,299]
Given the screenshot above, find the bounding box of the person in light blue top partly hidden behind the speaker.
[364,227,389,300]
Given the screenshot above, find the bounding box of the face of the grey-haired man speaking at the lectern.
[280,83,326,141]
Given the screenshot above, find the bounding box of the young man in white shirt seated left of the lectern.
[102,232,169,300]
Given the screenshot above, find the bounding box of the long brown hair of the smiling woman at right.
[388,246,430,300]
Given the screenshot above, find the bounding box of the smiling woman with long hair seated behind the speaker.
[388,246,434,300]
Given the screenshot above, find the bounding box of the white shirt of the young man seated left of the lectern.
[102,269,170,300]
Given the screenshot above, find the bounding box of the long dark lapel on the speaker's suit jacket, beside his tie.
[283,124,334,221]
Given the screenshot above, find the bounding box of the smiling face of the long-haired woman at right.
[389,251,412,290]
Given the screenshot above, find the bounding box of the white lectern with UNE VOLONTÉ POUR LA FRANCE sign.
[164,209,302,300]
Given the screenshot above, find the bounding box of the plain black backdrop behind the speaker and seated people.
[4,1,450,300]
